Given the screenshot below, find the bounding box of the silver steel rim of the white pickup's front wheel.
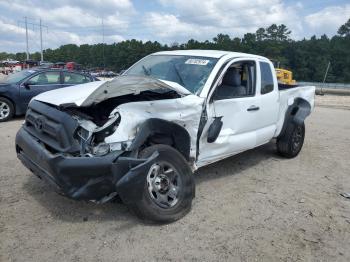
[147,161,182,209]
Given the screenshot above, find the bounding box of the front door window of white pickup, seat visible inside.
[213,61,256,100]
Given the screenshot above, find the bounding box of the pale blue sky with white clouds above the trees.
[0,0,350,52]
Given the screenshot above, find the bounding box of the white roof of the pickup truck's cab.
[154,49,266,59]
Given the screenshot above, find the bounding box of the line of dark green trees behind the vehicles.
[0,19,350,83]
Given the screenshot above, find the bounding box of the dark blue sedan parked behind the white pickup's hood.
[0,68,96,122]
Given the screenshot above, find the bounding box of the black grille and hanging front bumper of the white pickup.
[16,101,157,203]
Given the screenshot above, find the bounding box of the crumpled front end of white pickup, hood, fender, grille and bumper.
[16,74,202,203]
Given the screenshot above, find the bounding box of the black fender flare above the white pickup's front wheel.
[129,118,191,160]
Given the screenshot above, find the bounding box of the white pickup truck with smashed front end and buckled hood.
[16,50,315,222]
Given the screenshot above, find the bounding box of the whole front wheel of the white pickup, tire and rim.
[131,145,195,223]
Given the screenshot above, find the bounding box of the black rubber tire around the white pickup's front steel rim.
[130,145,195,223]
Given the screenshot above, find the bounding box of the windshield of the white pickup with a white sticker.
[124,55,218,93]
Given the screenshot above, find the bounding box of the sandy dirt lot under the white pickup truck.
[0,97,350,261]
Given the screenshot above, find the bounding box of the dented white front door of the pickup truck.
[197,59,261,166]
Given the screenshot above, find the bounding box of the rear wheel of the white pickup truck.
[277,122,305,158]
